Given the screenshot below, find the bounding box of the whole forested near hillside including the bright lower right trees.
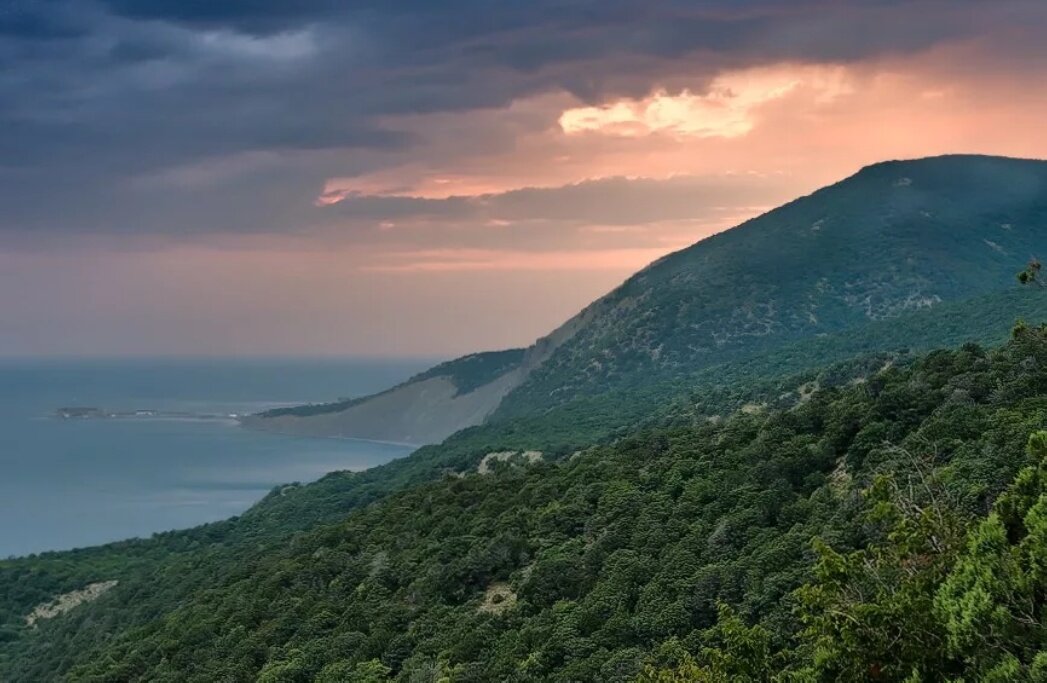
[5,326,1047,681]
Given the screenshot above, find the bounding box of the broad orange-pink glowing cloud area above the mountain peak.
[314,44,1047,213]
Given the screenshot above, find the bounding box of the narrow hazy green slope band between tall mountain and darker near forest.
[483,286,1047,442]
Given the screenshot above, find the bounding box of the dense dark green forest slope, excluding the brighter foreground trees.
[16,329,1047,681]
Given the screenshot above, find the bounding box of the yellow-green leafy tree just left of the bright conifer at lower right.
[797,469,963,681]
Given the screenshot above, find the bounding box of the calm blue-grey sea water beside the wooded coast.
[0,359,431,557]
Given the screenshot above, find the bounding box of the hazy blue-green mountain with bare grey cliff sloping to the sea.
[247,155,1047,443]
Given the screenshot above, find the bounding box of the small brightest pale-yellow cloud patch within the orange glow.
[559,65,851,138]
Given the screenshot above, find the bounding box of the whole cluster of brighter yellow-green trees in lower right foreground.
[797,432,1047,683]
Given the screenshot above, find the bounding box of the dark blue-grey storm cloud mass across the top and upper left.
[0,0,1044,234]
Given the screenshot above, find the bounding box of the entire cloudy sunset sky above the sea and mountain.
[0,0,1047,357]
